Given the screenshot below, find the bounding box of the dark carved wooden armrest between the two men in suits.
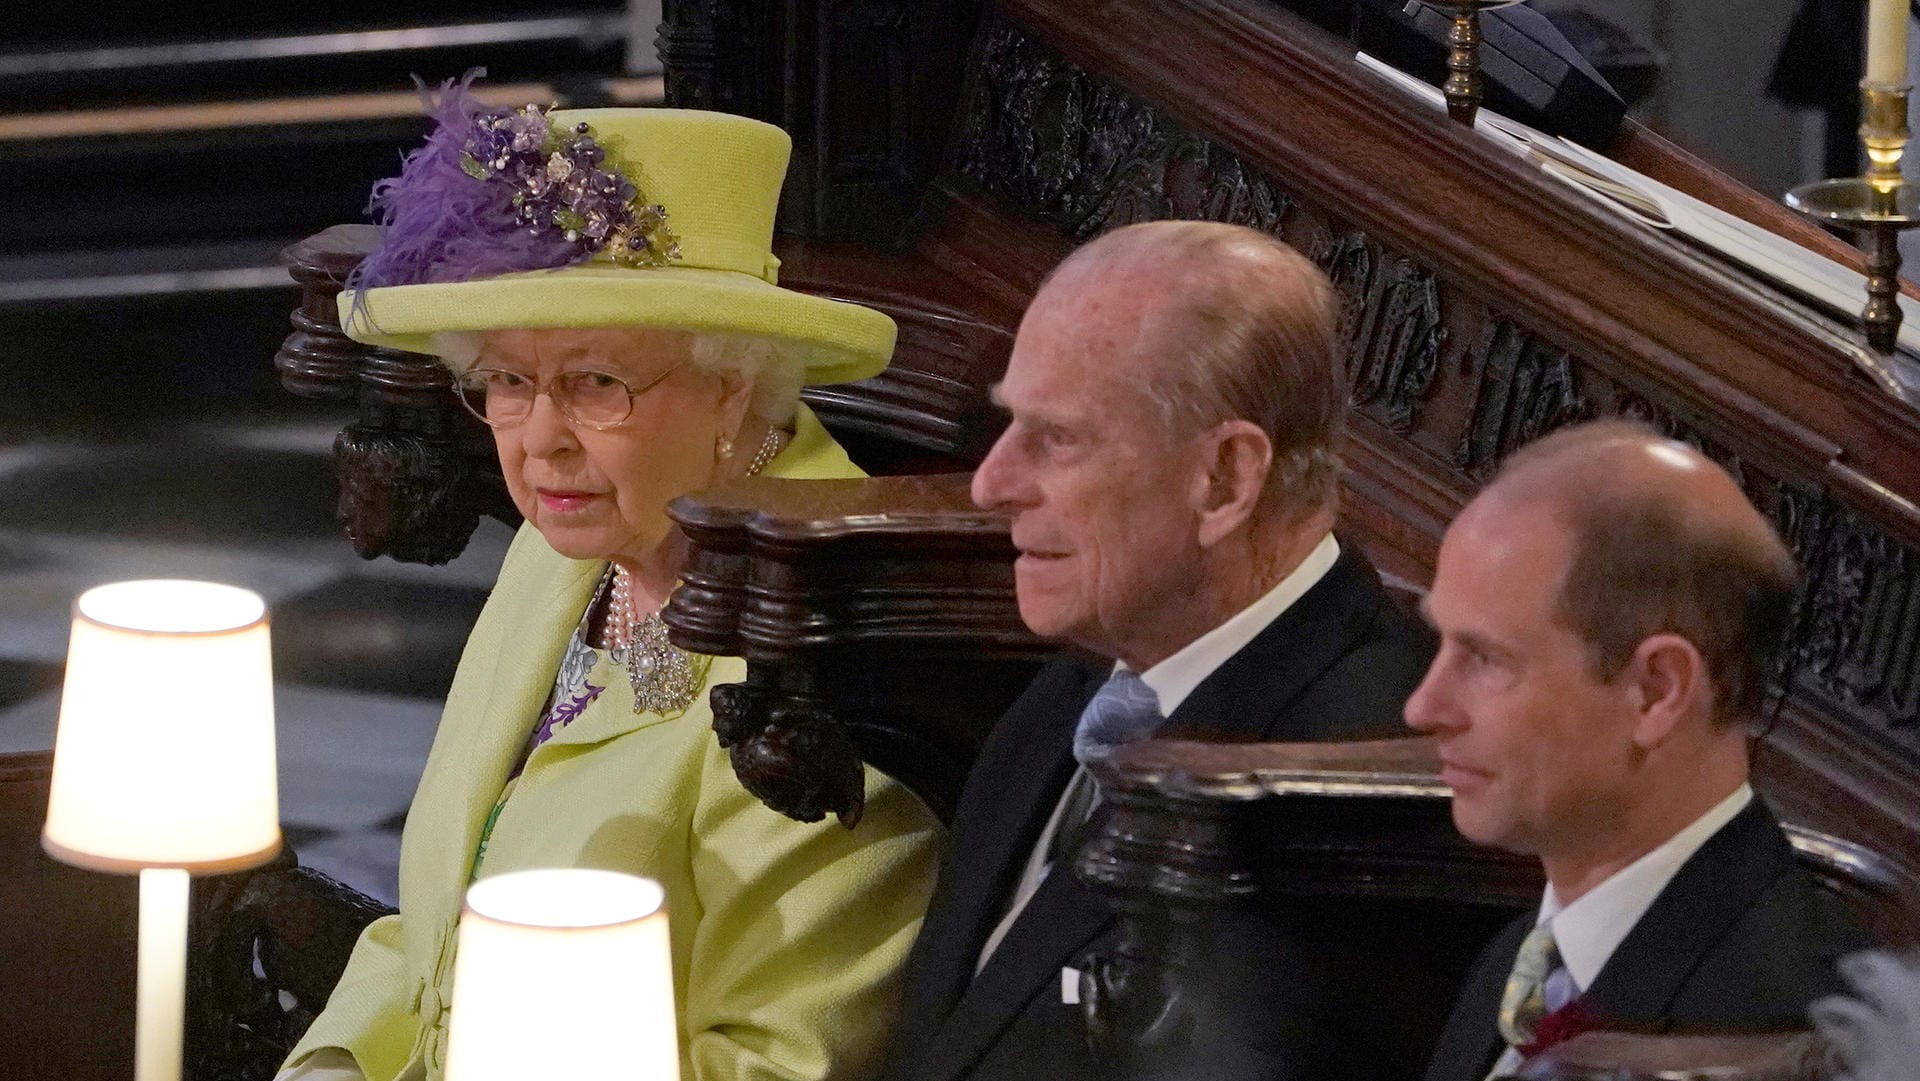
[1075,739,1540,1081]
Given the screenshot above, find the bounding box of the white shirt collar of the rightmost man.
[1534,783,1753,991]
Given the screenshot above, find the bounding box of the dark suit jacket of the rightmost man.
[1427,797,1874,1081]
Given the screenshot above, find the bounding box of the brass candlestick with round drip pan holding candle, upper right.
[1786,81,1920,353]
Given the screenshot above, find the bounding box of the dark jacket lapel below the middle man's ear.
[1158,545,1392,743]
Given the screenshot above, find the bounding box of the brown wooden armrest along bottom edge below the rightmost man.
[1515,1031,1839,1081]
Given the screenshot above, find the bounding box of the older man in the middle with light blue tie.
[889,221,1430,1081]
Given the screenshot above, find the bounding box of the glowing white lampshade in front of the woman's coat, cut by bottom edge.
[447,870,680,1081]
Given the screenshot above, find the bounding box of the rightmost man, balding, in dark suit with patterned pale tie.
[1407,420,1868,1081]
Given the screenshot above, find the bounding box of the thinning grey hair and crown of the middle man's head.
[1054,221,1348,516]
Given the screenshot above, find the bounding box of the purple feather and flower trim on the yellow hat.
[348,69,680,290]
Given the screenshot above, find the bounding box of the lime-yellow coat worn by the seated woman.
[288,407,939,1081]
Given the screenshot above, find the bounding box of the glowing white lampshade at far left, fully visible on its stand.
[40,580,280,874]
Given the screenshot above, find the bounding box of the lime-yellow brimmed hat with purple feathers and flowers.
[340,96,895,384]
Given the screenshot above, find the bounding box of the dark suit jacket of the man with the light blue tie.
[887,551,1432,1081]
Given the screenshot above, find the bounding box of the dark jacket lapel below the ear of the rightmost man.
[1586,797,1793,1029]
